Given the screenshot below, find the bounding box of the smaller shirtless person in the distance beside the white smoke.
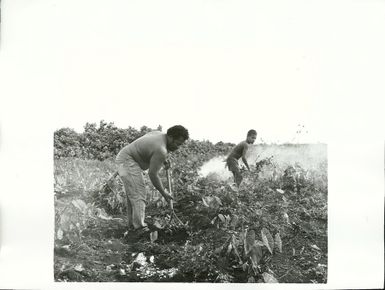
[226,129,257,187]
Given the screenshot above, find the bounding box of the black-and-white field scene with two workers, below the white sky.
[54,121,328,283]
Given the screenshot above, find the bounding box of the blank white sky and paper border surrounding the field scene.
[0,0,385,289]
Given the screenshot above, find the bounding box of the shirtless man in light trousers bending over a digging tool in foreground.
[116,125,189,232]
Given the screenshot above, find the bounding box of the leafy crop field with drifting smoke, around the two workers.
[54,143,328,283]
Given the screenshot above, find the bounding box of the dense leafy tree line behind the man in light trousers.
[54,120,234,160]
